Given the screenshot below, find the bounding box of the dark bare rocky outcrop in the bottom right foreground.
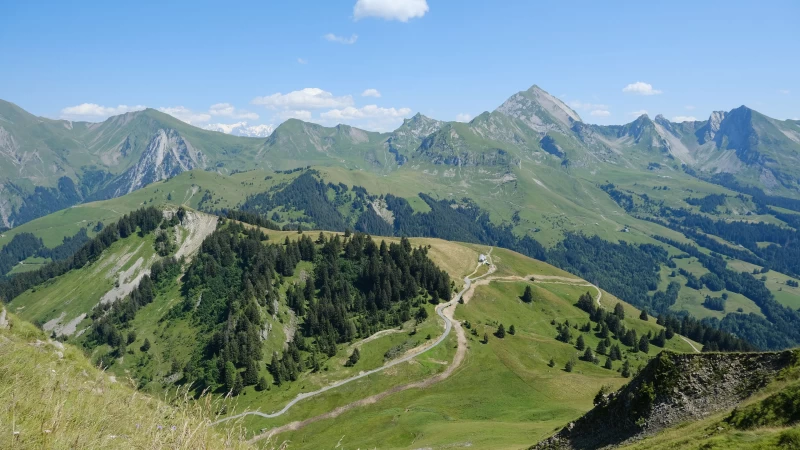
[531,351,798,450]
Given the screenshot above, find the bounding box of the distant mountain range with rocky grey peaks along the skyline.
[0,86,800,228]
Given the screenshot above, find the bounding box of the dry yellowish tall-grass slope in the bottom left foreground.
[0,314,249,449]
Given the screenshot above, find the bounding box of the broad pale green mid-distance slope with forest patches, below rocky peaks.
[6,160,800,348]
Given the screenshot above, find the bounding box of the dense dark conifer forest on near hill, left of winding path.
[161,223,452,393]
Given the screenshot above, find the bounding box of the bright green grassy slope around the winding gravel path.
[220,237,697,448]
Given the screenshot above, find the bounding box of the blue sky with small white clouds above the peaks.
[0,0,800,130]
